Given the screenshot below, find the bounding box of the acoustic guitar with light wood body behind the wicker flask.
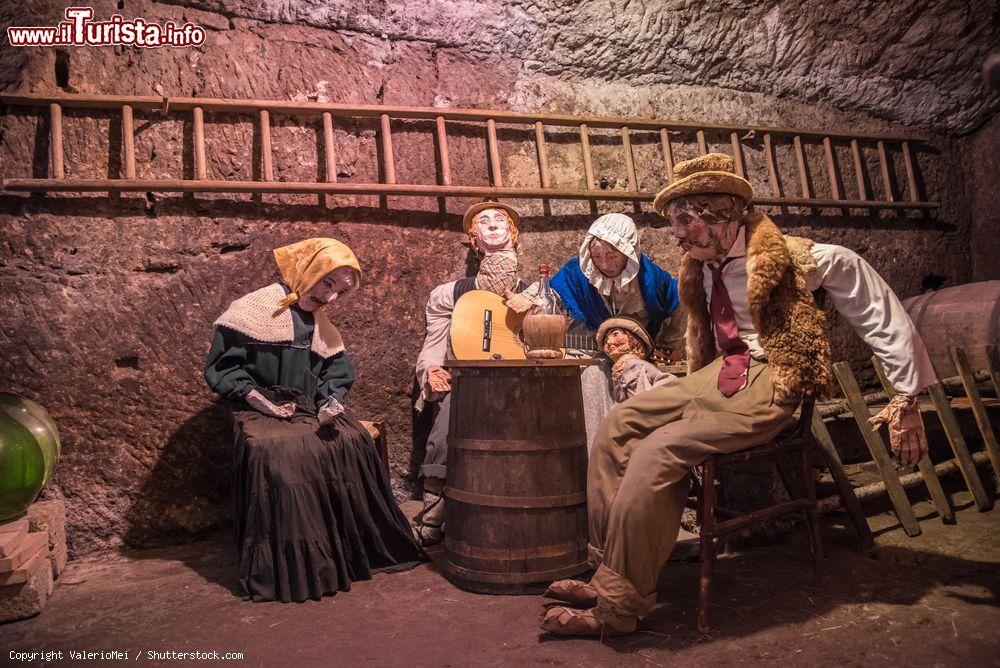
[451,290,597,360]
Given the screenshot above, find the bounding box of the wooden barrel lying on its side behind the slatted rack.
[903,281,1000,378]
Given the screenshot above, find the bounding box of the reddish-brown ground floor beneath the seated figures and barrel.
[0,493,1000,667]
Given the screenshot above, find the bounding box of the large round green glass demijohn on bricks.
[0,392,60,523]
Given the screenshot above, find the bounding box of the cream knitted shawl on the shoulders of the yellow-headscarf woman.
[215,283,344,359]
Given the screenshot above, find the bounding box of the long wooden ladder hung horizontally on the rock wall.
[0,88,938,210]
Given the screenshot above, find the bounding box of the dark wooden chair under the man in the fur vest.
[698,399,823,633]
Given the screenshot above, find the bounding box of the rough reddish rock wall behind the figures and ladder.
[0,0,997,554]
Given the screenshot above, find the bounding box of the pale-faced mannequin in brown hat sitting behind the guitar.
[414,202,525,545]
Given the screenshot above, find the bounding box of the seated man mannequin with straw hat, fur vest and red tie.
[542,153,935,635]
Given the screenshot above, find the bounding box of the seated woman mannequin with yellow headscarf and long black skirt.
[205,238,428,602]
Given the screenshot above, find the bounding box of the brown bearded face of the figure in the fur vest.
[667,194,744,262]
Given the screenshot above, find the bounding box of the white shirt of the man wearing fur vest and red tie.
[702,227,937,394]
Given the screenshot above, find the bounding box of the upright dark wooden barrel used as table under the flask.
[445,360,588,594]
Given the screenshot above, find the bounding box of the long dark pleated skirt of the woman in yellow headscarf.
[233,409,428,603]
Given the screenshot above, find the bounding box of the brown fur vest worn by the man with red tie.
[680,213,831,398]
